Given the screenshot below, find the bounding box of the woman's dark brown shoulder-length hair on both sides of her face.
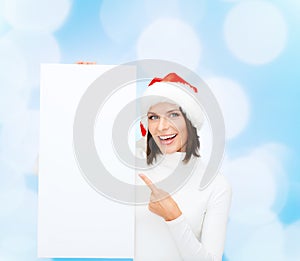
[146,108,200,165]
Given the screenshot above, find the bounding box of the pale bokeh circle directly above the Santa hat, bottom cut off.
[137,18,201,69]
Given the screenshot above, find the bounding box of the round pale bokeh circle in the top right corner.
[224,1,287,65]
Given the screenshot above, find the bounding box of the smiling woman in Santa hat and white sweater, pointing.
[135,73,231,261]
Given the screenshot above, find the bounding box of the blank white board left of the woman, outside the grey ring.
[38,64,136,258]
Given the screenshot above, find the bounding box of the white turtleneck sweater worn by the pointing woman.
[134,142,231,261]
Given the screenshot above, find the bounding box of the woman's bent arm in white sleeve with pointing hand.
[140,172,231,261]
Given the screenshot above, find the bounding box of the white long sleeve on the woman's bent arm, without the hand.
[166,177,231,261]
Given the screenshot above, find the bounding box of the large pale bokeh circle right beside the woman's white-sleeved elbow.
[223,144,286,224]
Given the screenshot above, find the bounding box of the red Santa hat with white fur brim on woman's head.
[140,73,204,136]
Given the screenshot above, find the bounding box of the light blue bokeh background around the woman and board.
[0,0,300,261]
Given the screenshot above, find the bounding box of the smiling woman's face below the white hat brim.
[147,102,188,154]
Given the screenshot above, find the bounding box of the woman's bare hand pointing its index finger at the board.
[139,174,182,221]
